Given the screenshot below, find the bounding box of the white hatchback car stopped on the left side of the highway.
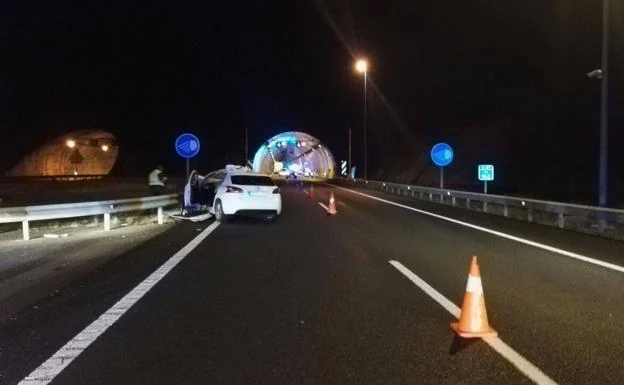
[201,166,282,223]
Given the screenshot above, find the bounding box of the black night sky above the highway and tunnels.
[0,0,624,201]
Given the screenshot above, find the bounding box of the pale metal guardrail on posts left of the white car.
[0,194,179,241]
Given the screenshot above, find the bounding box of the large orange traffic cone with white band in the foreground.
[451,257,498,338]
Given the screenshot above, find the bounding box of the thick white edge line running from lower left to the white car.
[18,222,219,385]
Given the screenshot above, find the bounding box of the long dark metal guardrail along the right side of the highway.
[346,179,624,239]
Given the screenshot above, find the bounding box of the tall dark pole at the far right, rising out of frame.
[598,0,609,207]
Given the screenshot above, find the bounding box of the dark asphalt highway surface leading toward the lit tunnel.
[0,185,624,384]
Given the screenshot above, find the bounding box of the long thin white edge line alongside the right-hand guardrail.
[328,183,624,273]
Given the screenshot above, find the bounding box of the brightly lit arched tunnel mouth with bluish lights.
[253,131,336,178]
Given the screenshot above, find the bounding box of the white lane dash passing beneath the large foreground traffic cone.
[389,261,557,385]
